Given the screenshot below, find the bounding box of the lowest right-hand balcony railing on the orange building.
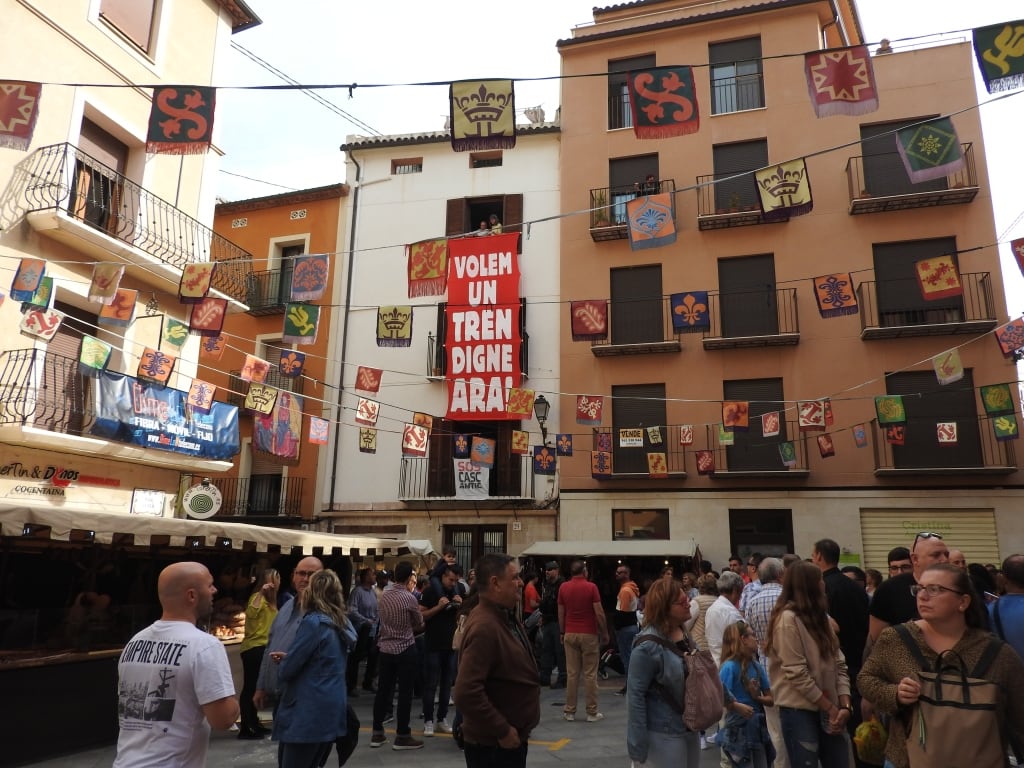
[870,417,1017,477]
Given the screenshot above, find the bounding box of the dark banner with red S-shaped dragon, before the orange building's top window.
[627,67,700,138]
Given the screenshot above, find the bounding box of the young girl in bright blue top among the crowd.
[718,622,775,768]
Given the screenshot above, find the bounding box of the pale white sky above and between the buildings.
[214,0,1024,307]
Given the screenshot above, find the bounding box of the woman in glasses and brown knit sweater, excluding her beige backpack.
[857,563,1024,768]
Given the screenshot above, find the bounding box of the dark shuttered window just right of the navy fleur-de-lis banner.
[718,254,778,337]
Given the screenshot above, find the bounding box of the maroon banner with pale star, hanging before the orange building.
[804,45,879,118]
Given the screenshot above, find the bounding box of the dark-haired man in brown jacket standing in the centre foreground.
[455,554,541,768]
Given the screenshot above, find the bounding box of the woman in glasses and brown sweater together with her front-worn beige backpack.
[857,563,1024,768]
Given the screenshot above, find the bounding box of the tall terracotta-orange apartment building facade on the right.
[558,0,1024,567]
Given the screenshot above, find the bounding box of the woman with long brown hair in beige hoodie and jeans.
[765,561,853,768]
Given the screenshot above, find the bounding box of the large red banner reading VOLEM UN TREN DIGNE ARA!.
[445,232,522,421]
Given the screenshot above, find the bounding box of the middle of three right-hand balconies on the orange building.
[857,272,996,340]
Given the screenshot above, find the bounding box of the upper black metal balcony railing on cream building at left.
[18,143,253,302]
